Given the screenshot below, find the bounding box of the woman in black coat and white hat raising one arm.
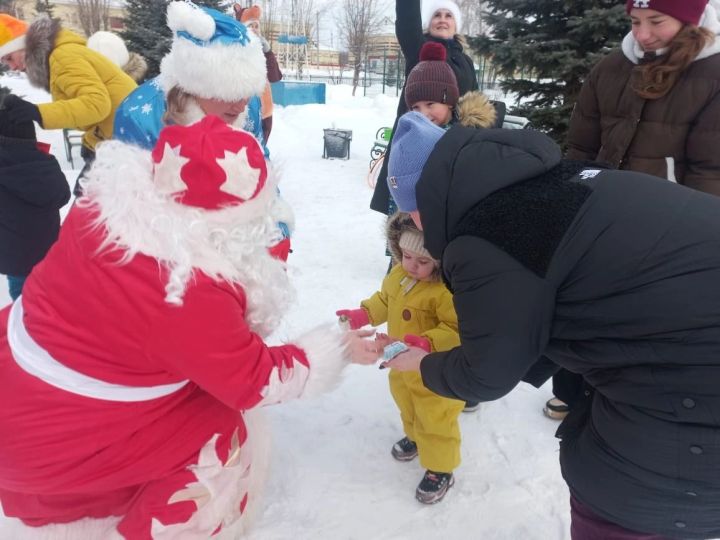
[370,0,486,215]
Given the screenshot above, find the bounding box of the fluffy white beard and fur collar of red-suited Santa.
[77,141,294,337]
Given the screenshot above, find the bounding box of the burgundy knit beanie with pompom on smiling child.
[405,41,460,108]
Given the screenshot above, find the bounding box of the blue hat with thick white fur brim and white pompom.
[160,1,267,101]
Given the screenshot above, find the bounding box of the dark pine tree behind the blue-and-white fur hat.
[120,0,229,78]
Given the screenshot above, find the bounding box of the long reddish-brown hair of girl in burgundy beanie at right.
[632,24,715,99]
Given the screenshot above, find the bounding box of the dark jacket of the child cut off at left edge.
[0,136,70,275]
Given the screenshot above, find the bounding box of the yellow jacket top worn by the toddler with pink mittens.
[360,264,460,352]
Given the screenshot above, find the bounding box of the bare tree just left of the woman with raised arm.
[338,0,381,96]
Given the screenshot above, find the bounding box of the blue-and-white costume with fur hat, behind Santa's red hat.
[114,2,268,156]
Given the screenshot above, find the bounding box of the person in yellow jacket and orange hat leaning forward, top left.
[0,14,137,195]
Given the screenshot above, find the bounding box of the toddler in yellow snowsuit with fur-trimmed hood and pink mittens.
[336,213,465,504]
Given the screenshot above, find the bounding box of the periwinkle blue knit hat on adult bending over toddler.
[387,111,445,212]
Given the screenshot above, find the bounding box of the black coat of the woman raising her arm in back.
[370,0,480,214]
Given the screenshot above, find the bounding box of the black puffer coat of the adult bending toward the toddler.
[416,127,720,538]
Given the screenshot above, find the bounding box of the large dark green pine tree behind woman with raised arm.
[469,0,630,145]
